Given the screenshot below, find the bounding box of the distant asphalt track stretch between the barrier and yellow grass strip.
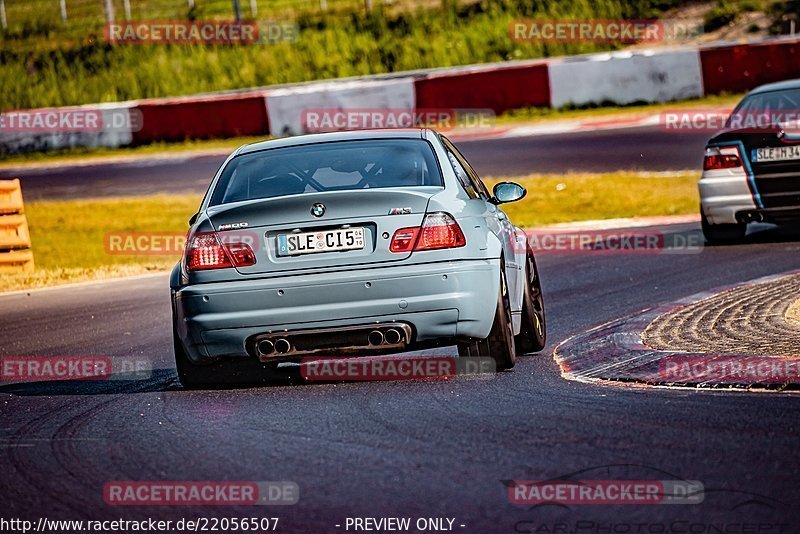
[0,126,709,200]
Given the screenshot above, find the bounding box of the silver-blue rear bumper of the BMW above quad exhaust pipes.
[173,259,500,362]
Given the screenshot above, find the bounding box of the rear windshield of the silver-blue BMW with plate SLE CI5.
[210,139,442,206]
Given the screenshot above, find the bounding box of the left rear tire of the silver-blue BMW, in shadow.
[172,331,278,389]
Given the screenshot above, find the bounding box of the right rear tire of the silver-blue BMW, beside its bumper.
[458,261,517,371]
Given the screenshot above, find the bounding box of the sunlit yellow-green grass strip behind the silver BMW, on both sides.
[0,172,698,291]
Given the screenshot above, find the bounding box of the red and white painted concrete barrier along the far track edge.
[0,38,800,154]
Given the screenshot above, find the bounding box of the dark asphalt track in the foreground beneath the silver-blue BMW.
[0,130,800,534]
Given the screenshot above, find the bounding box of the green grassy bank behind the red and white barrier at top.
[0,0,677,110]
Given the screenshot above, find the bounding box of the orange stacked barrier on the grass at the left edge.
[0,179,33,272]
